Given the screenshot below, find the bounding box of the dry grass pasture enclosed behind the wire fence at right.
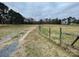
[39,25,79,48]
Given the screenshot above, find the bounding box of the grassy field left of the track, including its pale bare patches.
[0,24,33,48]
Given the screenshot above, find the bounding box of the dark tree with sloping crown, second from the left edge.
[8,9,24,24]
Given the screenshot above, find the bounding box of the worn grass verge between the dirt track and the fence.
[13,30,78,57]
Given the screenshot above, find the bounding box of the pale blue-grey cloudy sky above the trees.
[4,2,79,19]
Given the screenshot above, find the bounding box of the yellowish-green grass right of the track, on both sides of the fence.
[14,24,79,57]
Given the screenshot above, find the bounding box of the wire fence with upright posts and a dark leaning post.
[38,25,79,47]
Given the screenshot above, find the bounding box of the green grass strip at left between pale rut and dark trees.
[0,24,30,38]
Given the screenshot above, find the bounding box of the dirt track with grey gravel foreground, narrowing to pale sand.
[0,27,35,57]
